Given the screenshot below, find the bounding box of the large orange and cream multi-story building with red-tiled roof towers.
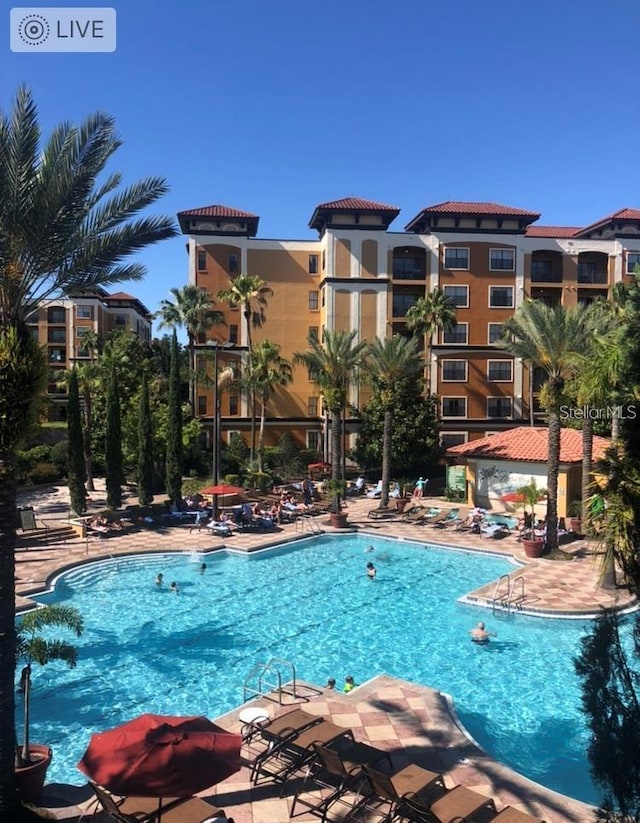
[178,197,640,458]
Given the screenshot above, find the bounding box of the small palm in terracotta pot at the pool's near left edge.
[16,605,83,803]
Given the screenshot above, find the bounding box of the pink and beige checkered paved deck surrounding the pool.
[16,486,634,823]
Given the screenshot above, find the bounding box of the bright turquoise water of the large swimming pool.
[21,536,600,802]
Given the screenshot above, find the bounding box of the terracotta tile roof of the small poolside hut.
[447,426,609,463]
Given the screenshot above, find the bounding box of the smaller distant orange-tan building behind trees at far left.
[28,289,151,421]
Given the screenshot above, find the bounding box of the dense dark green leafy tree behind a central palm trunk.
[352,378,442,476]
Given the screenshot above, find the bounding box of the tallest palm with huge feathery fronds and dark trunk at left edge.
[0,88,177,820]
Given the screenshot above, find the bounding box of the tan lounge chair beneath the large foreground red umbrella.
[89,781,226,823]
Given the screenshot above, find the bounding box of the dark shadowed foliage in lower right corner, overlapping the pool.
[575,609,640,820]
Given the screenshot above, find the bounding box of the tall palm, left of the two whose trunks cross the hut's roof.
[498,300,585,553]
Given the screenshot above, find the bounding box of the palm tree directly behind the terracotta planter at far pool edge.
[294,330,367,511]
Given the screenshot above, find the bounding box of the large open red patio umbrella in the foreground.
[78,714,242,820]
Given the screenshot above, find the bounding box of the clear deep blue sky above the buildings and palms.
[0,0,640,332]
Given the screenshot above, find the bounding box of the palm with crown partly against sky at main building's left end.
[154,284,225,414]
